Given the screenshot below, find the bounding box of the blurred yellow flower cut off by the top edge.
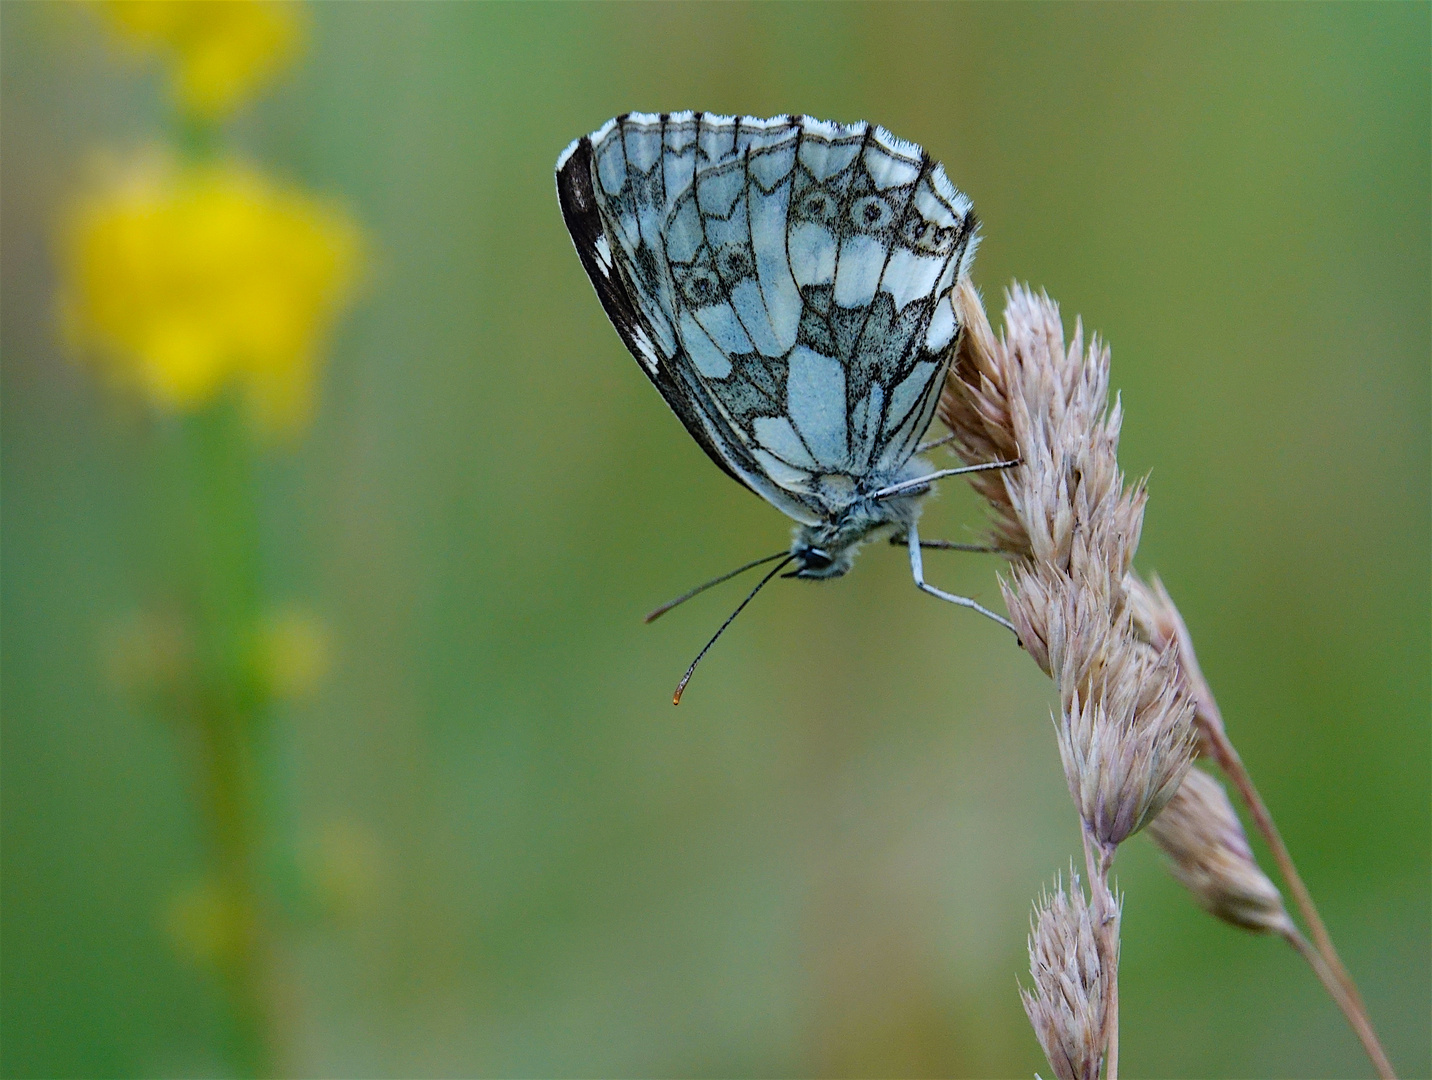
[102,0,301,117]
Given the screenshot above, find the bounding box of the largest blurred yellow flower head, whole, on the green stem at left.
[62,160,361,430]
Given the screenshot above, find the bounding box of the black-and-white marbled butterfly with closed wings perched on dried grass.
[557,112,1018,702]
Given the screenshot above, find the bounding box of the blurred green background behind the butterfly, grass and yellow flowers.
[0,3,1432,1077]
